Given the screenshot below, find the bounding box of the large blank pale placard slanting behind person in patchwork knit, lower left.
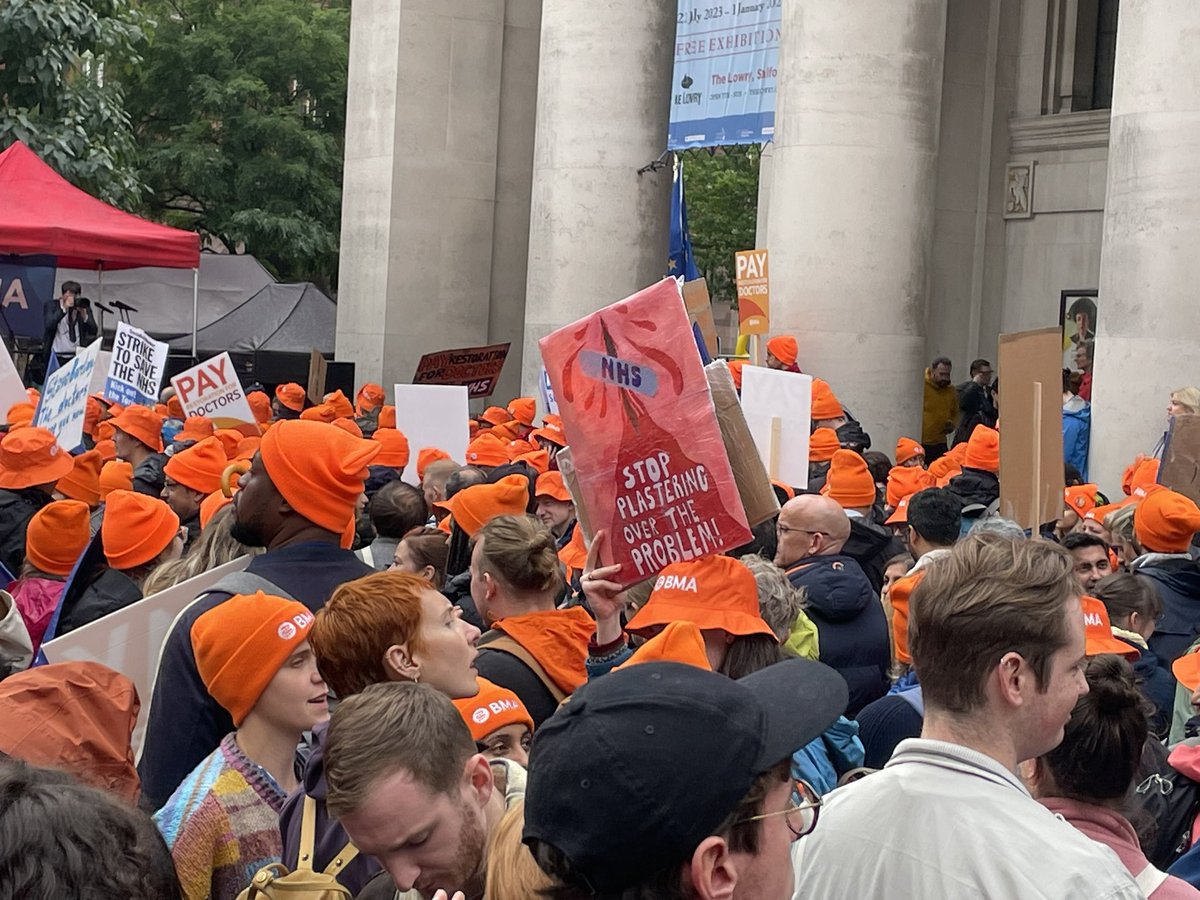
[42,557,251,752]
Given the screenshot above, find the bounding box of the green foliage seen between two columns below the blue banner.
[680,144,760,304]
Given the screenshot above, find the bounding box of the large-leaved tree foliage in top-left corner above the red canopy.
[0,0,144,208]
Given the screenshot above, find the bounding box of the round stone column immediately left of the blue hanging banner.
[522,0,676,392]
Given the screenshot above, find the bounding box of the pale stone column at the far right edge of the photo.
[1088,0,1200,497]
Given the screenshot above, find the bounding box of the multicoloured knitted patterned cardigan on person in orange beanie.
[154,734,287,900]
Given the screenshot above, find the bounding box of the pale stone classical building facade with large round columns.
[337,0,1200,490]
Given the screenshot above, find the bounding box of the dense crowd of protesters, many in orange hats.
[0,323,1200,900]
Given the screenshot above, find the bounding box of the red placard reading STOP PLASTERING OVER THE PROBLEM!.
[540,278,750,586]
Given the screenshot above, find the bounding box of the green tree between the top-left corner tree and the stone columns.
[130,0,349,286]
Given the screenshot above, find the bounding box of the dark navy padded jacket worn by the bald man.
[787,554,892,718]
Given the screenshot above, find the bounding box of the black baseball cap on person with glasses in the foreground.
[523,659,850,892]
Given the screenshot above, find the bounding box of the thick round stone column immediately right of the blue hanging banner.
[768,0,950,455]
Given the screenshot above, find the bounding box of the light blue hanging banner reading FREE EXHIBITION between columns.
[667,0,784,150]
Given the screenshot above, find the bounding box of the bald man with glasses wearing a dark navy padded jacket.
[775,494,892,718]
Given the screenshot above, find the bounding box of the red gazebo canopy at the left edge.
[0,140,200,269]
